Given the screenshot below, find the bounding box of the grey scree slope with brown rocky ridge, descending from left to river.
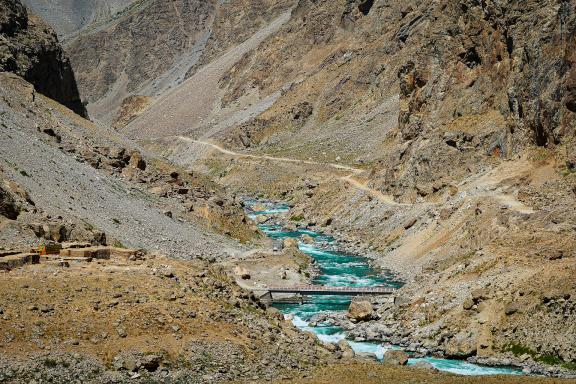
[0,74,255,258]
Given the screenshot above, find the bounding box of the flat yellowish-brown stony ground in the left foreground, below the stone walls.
[0,255,340,382]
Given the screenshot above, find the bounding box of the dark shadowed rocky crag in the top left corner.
[0,0,87,117]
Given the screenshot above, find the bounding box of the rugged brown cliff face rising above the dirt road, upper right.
[385,1,576,198]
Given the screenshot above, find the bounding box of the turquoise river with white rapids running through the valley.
[245,200,521,375]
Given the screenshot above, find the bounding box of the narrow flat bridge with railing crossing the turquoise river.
[260,285,396,303]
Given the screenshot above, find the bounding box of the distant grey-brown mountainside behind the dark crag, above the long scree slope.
[46,0,291,123]
